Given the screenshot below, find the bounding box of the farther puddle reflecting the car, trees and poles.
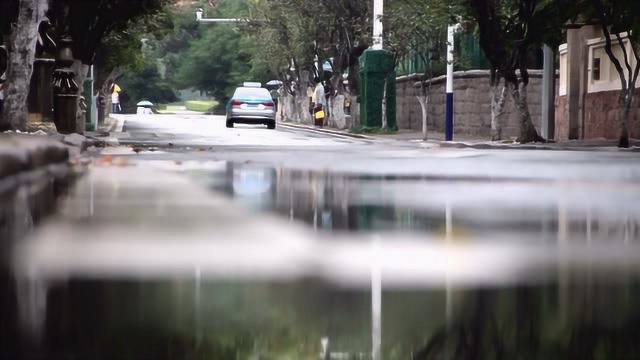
[210,164,640,244]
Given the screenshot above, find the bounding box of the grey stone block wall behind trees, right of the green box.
[396,70,542,139]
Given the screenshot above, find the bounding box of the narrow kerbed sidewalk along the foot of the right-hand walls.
[279,122,640,152]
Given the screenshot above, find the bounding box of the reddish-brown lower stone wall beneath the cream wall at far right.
[556,90,640,140]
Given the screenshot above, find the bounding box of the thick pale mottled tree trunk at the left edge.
[0,0,49,131]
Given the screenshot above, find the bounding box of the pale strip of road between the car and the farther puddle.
[110,115,640,183]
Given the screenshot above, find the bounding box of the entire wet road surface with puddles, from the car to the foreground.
[5,115,640,359]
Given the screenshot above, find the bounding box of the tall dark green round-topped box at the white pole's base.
[360,49,398,131]
